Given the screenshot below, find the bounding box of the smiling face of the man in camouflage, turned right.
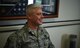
[30,8,43,25]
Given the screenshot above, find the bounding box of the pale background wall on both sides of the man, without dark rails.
[0,0,80,48]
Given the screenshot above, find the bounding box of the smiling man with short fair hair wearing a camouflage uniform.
[4,4,54,48]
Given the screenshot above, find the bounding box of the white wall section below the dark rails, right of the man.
[46,25,79,48]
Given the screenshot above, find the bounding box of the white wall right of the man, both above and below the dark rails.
[45,0,80,48]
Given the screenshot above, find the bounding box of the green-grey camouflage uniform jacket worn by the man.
[4,25,54,48]
